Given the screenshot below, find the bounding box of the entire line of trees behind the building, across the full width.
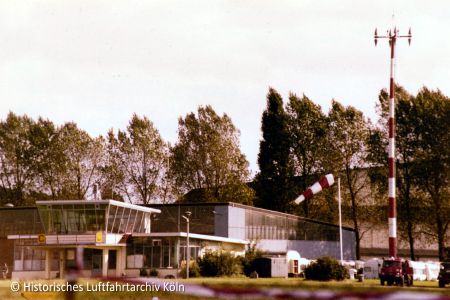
[0,86,450,259]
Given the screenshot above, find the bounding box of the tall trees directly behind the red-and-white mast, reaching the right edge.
[369,86,450,260]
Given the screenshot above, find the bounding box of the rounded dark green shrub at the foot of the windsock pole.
[305,256,348,281]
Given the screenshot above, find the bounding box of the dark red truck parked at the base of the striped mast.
[379,257,413,286]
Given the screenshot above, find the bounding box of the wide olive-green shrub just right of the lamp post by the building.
[198,252,242,277]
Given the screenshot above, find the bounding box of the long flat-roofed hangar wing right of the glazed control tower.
[149,202,355,260]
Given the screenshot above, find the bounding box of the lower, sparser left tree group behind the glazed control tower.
[0,106,253,206]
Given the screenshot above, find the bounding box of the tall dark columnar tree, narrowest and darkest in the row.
[256,88,295,212]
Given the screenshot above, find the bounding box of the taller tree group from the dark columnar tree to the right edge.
[254,86,450,260]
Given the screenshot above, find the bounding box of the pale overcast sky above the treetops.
[0,0,450,172]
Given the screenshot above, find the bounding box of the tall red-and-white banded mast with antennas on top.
[374,27,412,257]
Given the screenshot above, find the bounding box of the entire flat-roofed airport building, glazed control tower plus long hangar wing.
[0,200,355,279]
